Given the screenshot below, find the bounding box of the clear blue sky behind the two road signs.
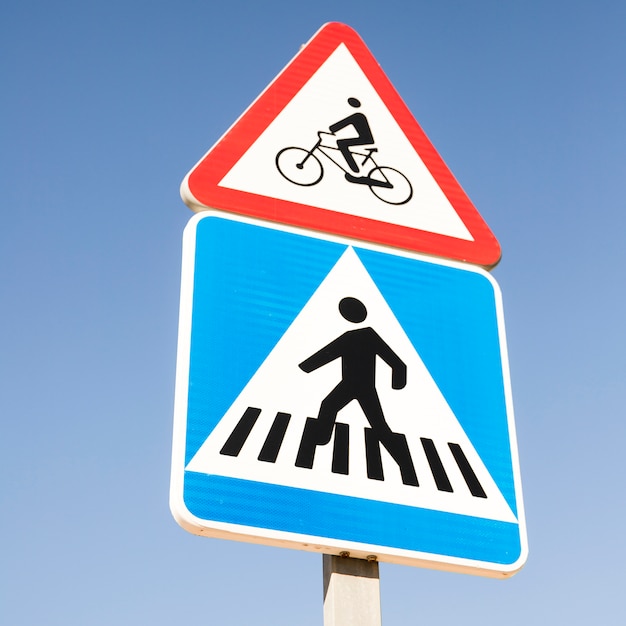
[0,0,626,626]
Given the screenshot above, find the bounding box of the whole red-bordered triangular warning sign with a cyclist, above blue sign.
[181,23,500,267]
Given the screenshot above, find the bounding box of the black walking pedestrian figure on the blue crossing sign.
[296,297,418,485]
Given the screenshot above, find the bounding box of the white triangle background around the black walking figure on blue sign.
[186,247,517,523]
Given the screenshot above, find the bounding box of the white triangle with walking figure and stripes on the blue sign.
[186,247,517,523]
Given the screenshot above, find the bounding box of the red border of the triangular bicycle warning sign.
[181,22,501,268]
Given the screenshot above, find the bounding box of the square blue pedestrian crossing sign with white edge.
[171,211,527,576]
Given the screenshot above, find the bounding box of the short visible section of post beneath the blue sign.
[324,553,382,626]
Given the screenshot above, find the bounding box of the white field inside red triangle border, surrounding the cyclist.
[219,44,473,241]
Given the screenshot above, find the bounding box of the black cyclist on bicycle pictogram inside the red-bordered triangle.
[275,98,413,205]
